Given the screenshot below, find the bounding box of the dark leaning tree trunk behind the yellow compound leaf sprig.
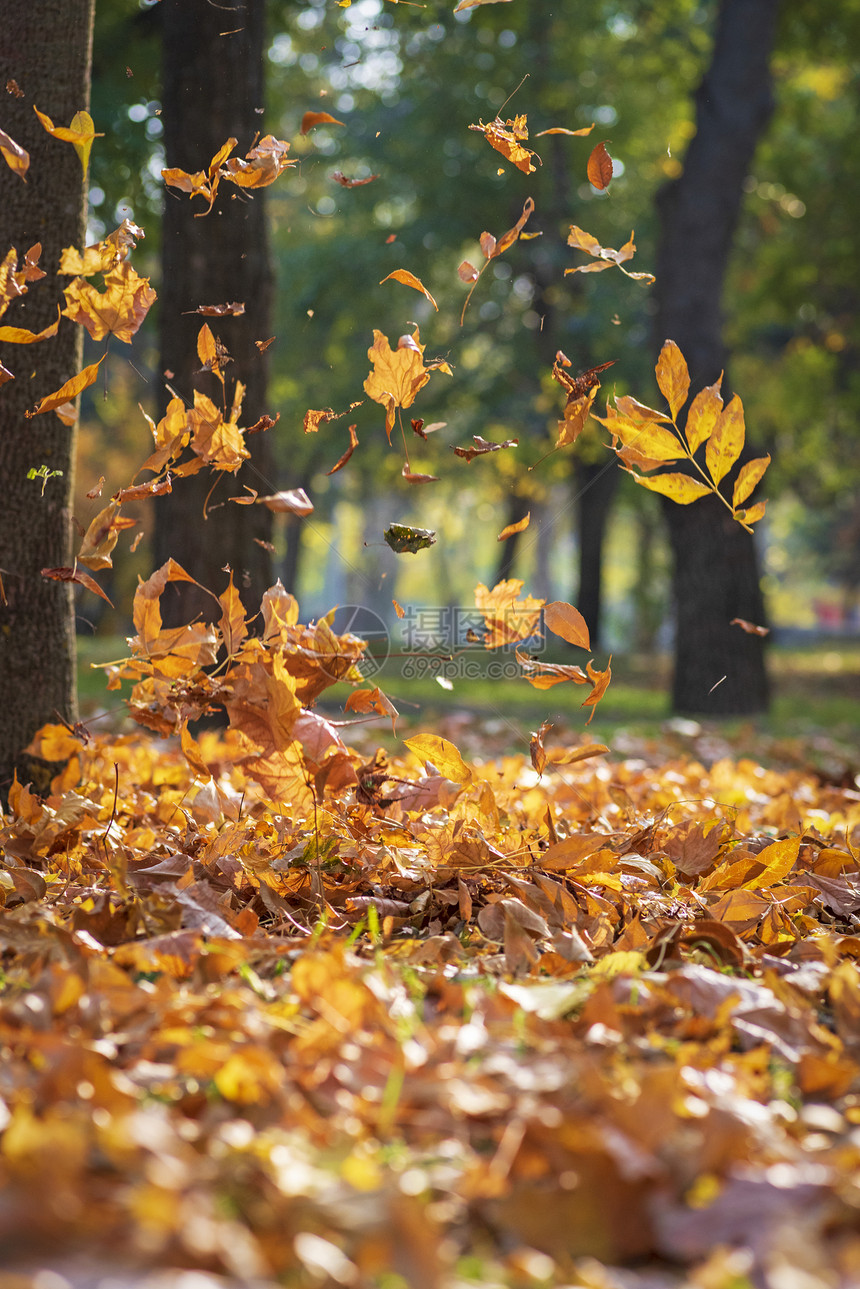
[656,0,779,715]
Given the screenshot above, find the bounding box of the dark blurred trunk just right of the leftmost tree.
[153,0,276,623]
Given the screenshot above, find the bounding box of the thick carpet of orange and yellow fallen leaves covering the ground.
[0,592,860,1289]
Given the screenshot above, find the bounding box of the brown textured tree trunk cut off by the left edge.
[0,0,98,795]
